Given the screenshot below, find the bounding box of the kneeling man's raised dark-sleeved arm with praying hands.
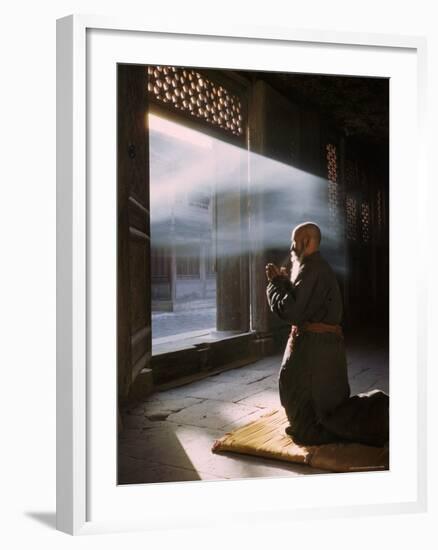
[266,264,317,325]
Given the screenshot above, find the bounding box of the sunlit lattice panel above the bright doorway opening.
[148,65,243,136]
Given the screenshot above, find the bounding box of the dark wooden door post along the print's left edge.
[117,64,152,398]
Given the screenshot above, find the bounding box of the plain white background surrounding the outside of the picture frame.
[0,0,438,550]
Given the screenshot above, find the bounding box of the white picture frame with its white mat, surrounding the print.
[57,15,427,534]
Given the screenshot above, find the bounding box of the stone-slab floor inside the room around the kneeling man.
[119,339,389,484]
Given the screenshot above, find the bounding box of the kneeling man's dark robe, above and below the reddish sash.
[266,252,389,445]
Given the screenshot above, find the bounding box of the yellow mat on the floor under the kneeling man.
[212,409,389,472]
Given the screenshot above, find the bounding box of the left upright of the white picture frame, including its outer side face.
[56,15,86,535]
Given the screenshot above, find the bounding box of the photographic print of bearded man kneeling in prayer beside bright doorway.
[117,64,390,485]
